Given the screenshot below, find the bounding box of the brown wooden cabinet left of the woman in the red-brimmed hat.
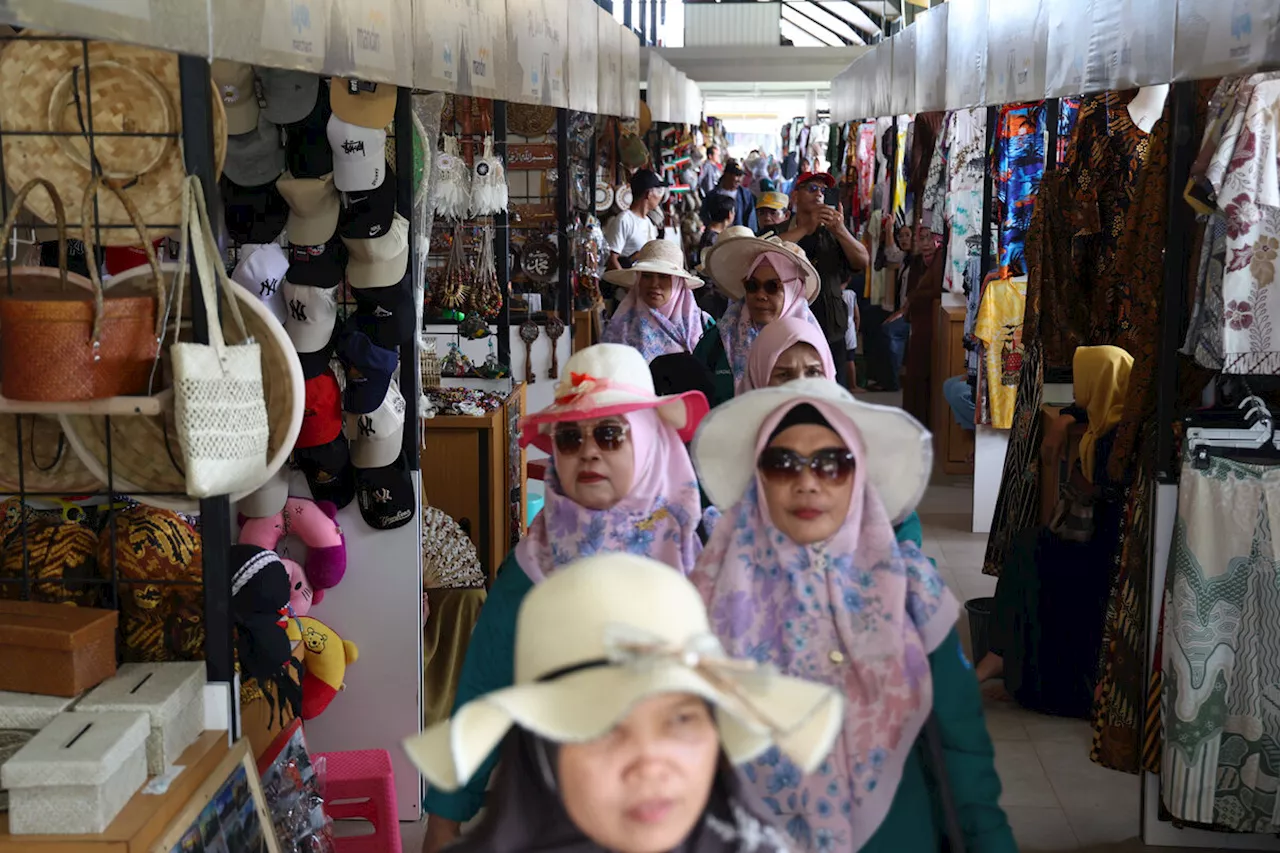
[421,383,526,581]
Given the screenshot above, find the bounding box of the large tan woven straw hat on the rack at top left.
[0,32,227,246]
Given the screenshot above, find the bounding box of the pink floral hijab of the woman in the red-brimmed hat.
[516,409,701,584]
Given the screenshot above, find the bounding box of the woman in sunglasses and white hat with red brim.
[422,343,707,853]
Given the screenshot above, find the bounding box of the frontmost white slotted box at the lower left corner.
[0,711,151,835]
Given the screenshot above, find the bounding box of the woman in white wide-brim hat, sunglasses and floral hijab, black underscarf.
[691,379,1016,853]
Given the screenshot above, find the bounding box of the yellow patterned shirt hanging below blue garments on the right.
[973,277,1027,429]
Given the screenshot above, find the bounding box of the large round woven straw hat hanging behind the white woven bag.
[59,264,305,512]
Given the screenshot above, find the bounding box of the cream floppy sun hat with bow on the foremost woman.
[404,553,844,790]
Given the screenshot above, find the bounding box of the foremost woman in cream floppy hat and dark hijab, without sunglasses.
[404,553,842,853]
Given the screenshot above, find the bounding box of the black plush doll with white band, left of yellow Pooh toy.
[230,544,302,725]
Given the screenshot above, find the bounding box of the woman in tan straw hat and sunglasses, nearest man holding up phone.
[694,228,819,406]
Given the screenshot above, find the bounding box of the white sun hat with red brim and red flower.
[520,343,708,453]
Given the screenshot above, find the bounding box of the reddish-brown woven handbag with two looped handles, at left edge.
[0,177,164,402]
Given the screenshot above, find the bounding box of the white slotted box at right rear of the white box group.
[77,663,205,776]
